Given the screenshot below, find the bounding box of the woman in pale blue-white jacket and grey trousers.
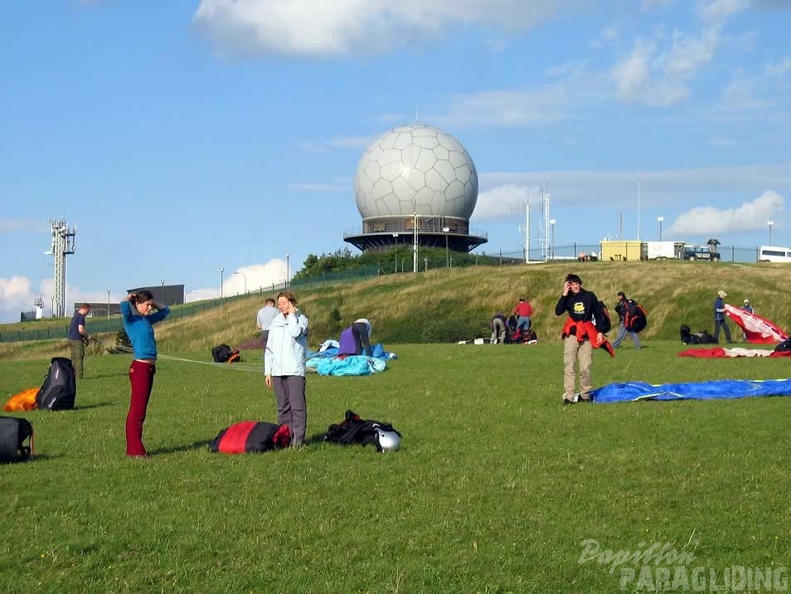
[264,291,308,446]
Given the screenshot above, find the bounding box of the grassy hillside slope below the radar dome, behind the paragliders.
[0,261,791,359]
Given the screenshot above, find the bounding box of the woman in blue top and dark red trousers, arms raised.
[121,290,170,458]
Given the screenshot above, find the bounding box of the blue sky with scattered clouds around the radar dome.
[0,0,791,322]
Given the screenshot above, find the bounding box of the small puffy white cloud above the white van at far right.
[668,190,785,236]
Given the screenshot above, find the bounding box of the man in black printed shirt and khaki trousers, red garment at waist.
[555,274,614,404]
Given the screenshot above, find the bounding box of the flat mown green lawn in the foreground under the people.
[0,340,791,593]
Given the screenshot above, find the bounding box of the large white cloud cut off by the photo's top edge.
[193,0,590,57]
